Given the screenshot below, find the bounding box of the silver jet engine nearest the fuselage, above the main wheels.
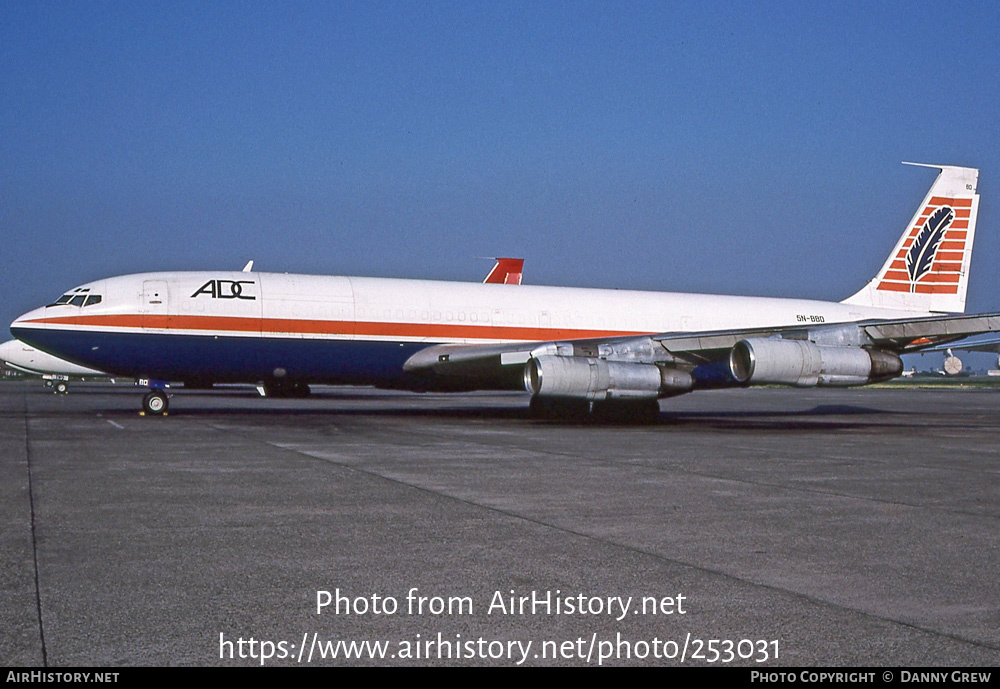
[524,355,694,400]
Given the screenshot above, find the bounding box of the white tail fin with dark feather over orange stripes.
[841,163,979,313]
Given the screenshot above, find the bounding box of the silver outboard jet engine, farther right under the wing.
[729,338,903,387]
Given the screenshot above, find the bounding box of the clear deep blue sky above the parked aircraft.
[0,0,1000,366]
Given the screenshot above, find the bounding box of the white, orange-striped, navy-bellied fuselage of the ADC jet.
[11,272,915,384]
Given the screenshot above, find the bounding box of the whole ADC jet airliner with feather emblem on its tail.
[11,166,1000,415]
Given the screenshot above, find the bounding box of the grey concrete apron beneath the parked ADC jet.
[0,382,1000,668]
